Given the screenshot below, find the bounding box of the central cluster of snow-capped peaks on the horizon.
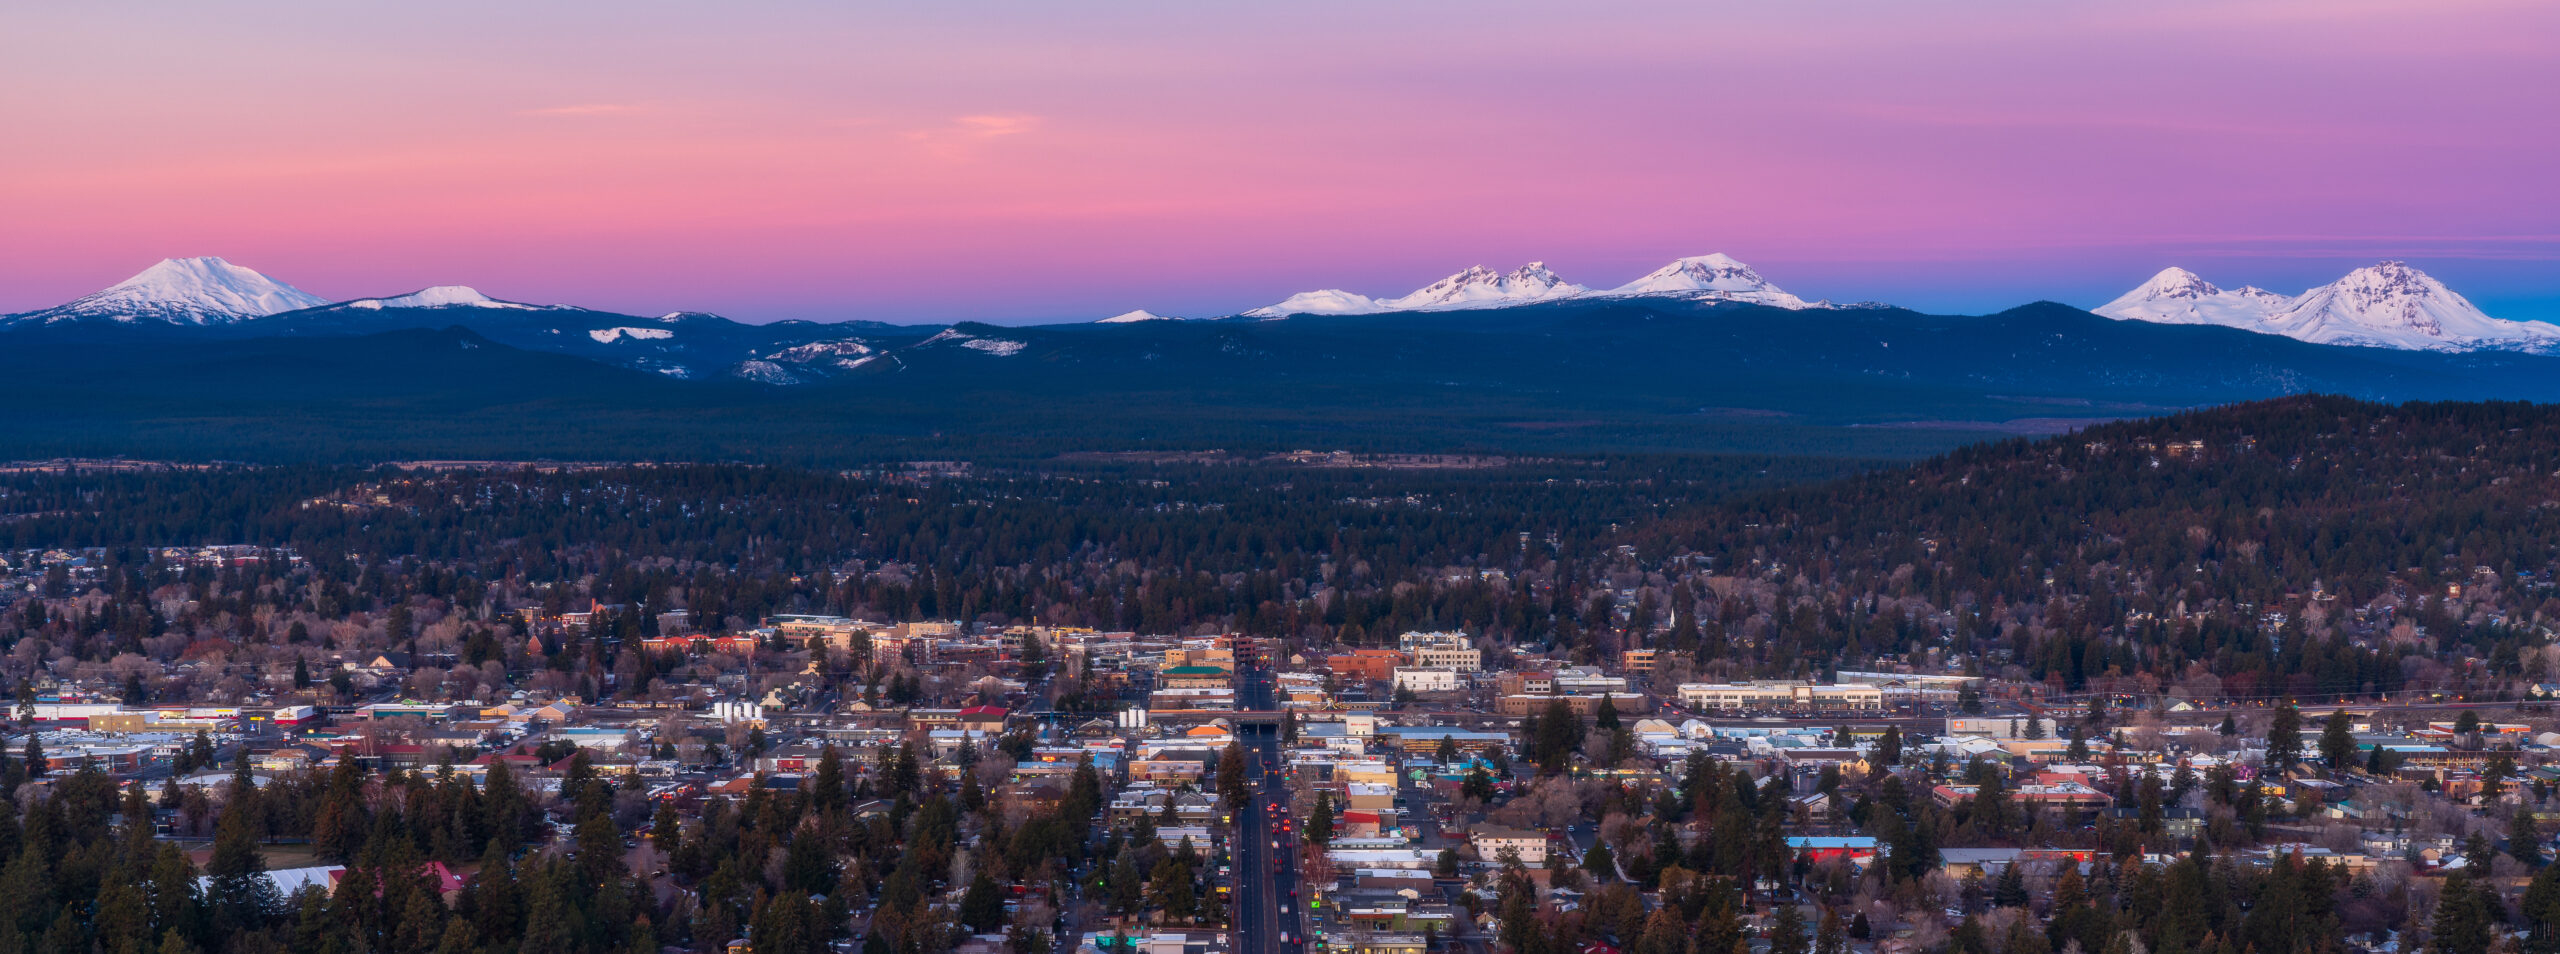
[1244,253,1836,317]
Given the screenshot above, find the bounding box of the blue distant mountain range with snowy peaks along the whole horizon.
[0,256,2560,460]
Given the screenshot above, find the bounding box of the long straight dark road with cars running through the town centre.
[1234,662,1306,954]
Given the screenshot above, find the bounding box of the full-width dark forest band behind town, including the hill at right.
[0,396,2560,698]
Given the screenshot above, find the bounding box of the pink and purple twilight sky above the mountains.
[0,0,2560,322]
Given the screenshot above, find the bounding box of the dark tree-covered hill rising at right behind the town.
[1646,396,2560,698]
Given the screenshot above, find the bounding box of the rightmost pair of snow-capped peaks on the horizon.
[2097,261,2560,353]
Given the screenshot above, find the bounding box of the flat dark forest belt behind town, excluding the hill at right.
[0,458,1856,647]
